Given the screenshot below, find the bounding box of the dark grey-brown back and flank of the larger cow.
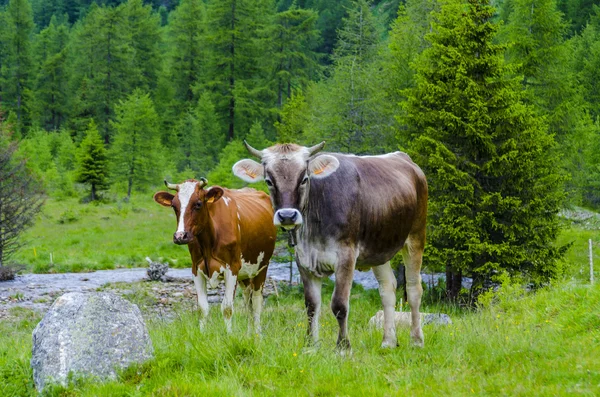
[308,152,427,266]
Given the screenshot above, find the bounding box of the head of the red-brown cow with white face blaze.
[154,178,223,244]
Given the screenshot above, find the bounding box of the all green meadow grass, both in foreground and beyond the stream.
[0,195,600,397]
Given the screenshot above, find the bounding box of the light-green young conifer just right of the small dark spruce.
[111,89,160,199]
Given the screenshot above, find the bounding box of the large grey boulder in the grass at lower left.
[31,292,154,391]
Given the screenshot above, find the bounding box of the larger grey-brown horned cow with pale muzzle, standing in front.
[233,142,427,350]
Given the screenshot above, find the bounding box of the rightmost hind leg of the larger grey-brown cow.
[402,236,424,347]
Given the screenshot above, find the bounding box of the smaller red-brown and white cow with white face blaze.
[154,178,276,333]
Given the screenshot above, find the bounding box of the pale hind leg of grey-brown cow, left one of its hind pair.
[373,262,398,348]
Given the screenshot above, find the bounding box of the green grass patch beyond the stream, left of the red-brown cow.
[14,194,190,273]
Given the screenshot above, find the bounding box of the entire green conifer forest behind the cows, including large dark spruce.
[0,0,600,296]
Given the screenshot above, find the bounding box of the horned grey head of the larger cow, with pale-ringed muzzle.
[233,142,340,229]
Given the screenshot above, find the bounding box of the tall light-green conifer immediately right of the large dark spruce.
[502,0,595,204]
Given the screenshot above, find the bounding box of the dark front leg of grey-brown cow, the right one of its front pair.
[331,251,356,353]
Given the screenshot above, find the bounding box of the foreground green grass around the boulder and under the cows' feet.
[0,283,600,396]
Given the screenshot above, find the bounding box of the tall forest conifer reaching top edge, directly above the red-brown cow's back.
[207,0,274,141]
